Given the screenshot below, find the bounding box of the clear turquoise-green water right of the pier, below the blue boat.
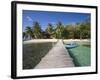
[68,45,91,66]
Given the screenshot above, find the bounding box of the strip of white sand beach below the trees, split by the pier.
[23,39,91,44]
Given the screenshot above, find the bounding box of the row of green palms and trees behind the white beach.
[23,20,91,40]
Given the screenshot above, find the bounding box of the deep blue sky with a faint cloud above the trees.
[22,10,90,31]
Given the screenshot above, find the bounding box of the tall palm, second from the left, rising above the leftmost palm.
[33,21,42,39]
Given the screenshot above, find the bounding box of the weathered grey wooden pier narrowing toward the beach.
[35,40,74,69]
